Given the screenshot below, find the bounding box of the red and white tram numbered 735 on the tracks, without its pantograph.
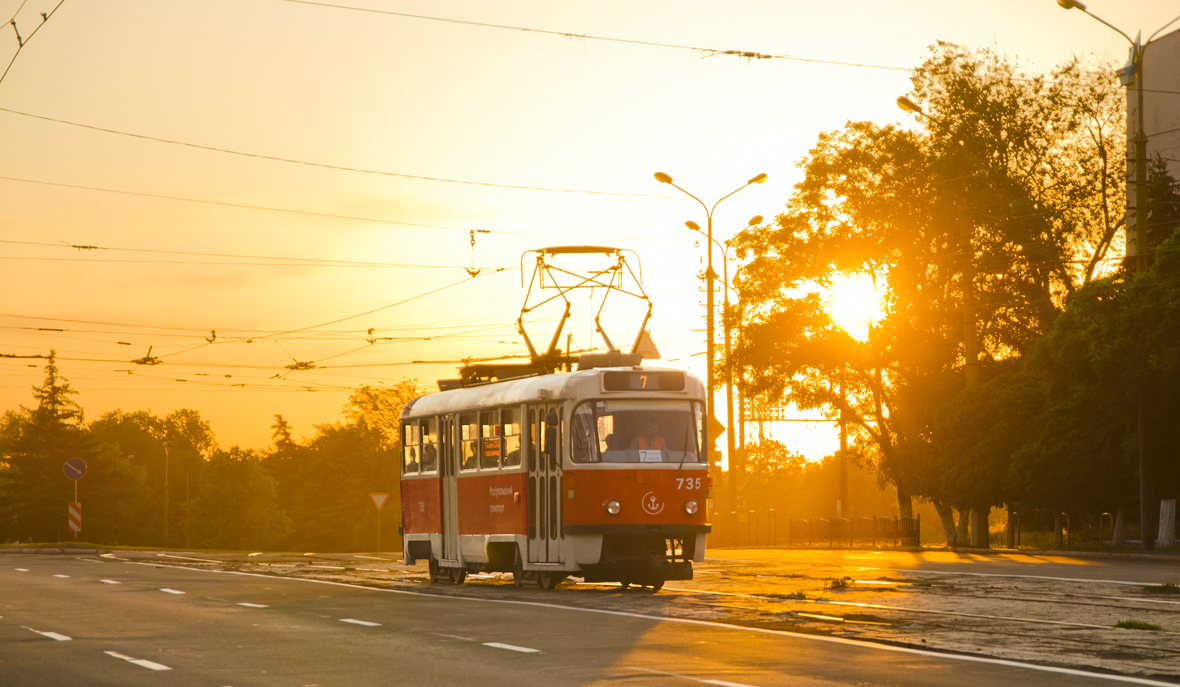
[401,365,709,589]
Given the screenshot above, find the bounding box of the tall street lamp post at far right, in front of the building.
[1057,0,1180,551]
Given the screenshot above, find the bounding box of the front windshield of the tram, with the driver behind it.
[571,399,702,463]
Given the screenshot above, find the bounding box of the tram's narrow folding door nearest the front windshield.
[527,404,562,563]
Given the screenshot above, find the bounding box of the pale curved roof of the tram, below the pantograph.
[401,367,704,419]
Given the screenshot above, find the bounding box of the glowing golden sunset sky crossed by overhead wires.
[0,0,1178,458]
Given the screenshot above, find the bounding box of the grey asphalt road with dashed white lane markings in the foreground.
[0,555,1175,687]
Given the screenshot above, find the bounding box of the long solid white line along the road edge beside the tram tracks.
[119,558,1176,687]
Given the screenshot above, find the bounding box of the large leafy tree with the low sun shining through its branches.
[730,44,1122,543]
